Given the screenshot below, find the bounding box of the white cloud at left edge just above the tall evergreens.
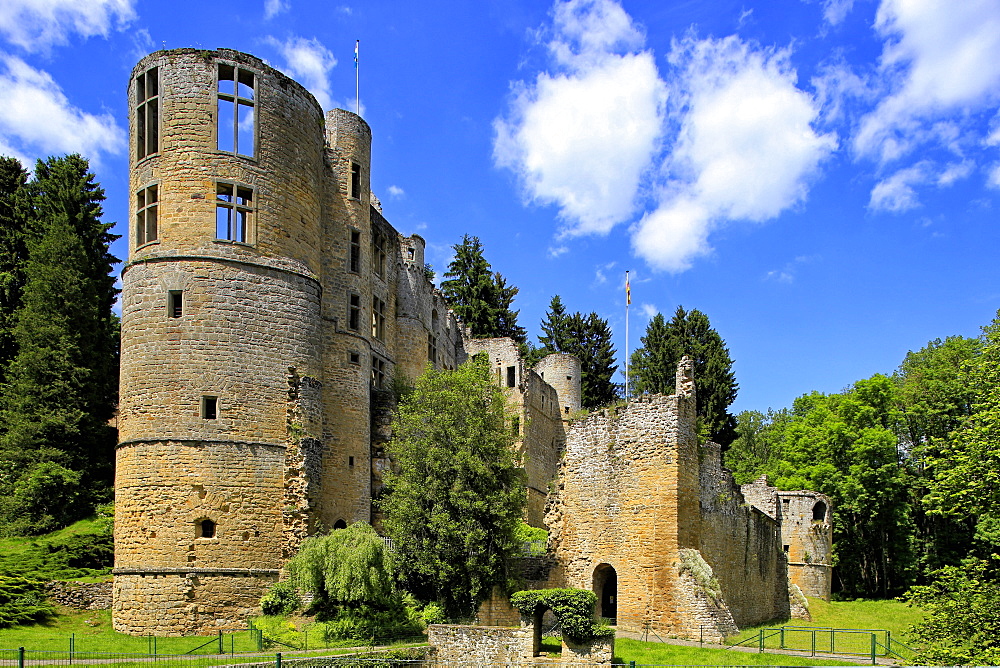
[0,54,125,168]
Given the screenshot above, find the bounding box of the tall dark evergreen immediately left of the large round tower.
[0,156,118,532]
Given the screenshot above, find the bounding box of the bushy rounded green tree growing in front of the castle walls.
[381,355,525,618]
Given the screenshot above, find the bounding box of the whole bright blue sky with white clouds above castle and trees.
[0,0,1000,410]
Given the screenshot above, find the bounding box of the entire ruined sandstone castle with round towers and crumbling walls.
[113,49,829,634]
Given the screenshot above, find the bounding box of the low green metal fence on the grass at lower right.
[729,626,916,665]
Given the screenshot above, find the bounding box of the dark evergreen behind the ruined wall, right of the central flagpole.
[629,306,739,448]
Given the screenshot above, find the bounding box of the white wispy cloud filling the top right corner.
[854,0,1000,162]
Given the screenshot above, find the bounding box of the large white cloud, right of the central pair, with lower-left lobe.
[632,36,837,272]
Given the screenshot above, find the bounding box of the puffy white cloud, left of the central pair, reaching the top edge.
[494,0,666,235]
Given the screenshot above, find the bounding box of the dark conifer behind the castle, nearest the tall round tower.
[441,234,527,344]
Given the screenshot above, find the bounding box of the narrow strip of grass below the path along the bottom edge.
[615,638,854,666]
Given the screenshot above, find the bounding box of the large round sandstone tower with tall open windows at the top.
[114,49,324,634]
